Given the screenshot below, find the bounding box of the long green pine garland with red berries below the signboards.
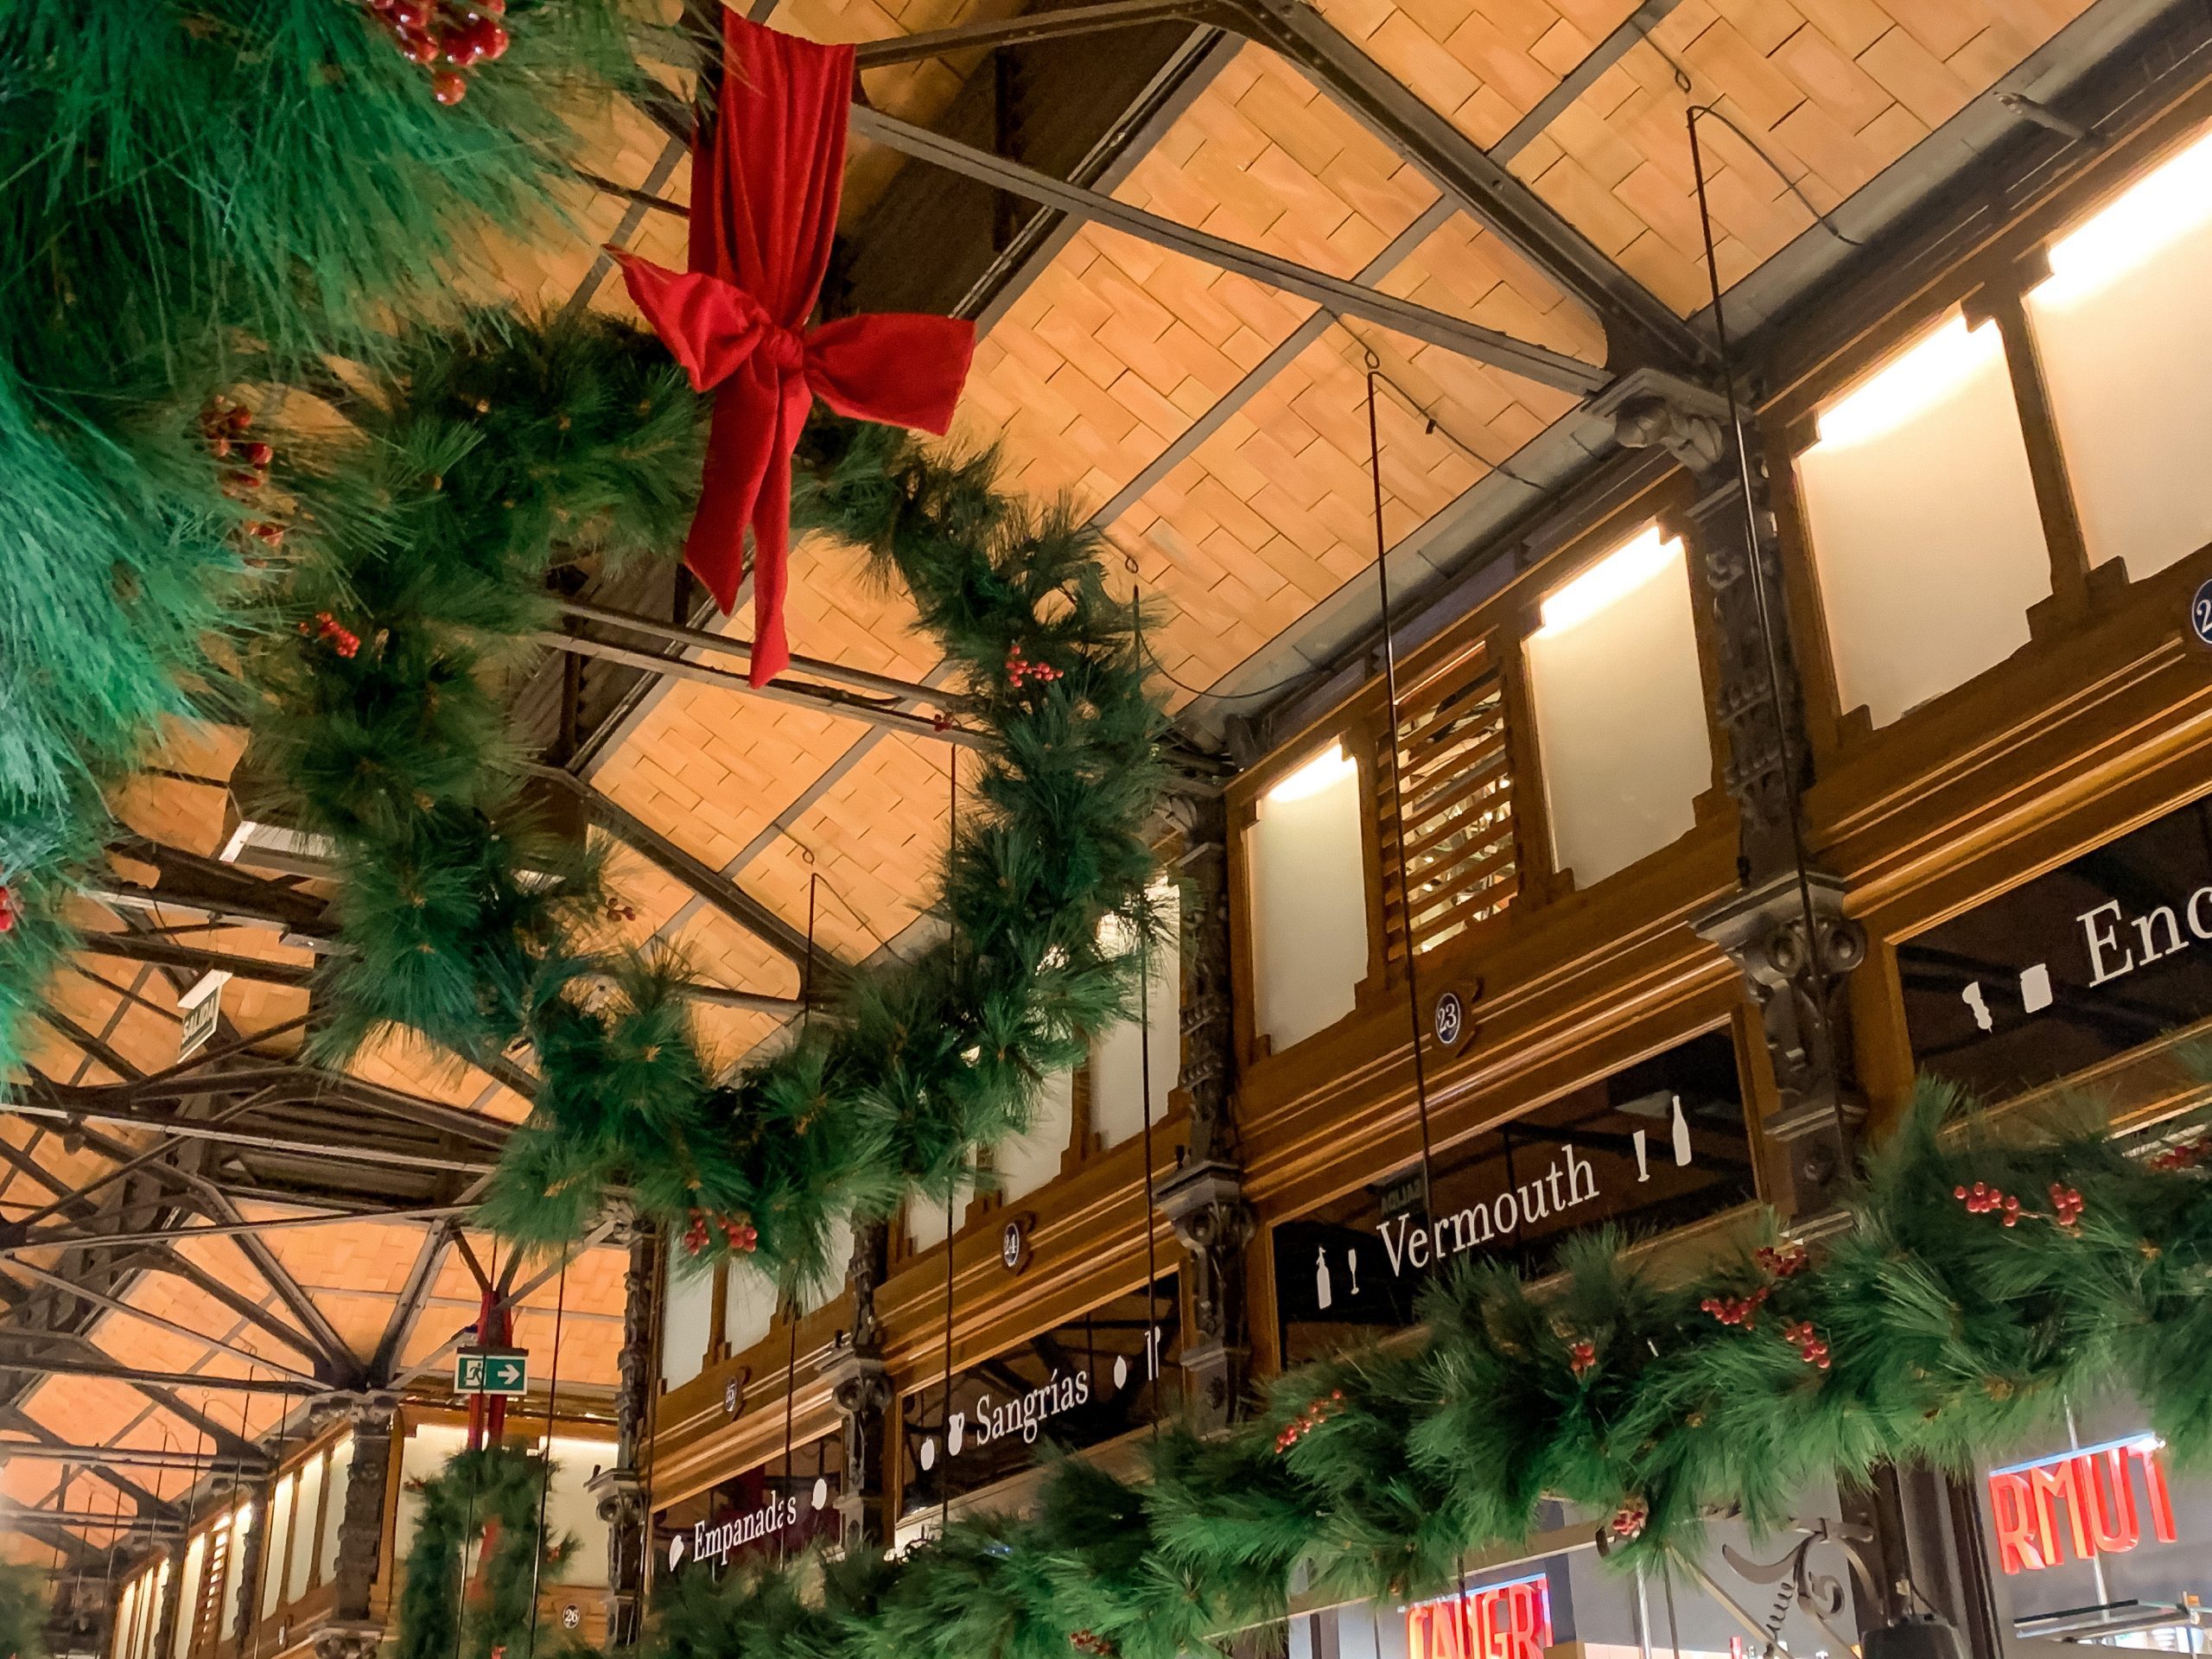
[614,1084,2212,1659]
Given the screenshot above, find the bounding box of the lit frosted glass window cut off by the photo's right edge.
[2029,124,2212,577]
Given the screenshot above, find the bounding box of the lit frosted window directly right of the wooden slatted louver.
[1526,524,1712,887]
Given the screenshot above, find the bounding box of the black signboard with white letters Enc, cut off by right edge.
[1897,801,2212,1099]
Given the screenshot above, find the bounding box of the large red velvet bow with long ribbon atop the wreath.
[608,11,976,686]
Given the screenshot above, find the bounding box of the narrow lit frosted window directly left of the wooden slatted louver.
[1245,743,1367,1053]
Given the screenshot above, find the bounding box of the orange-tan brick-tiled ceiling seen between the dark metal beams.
[0,0,2114,1560]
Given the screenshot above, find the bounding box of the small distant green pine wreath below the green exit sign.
[396,1446,575,1659]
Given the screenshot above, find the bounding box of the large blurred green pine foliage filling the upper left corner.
[0,0,654,1066]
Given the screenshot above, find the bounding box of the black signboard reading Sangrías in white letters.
[900,1274,1184,1516]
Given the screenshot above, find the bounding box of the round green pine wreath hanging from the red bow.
[252,315,1164,1281]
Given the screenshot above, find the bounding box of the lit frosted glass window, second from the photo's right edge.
[1796,315,2050,726]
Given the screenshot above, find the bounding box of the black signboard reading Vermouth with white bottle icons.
[1274,1031,1757,1365]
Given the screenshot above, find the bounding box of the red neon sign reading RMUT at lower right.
[1988,1433,2177,1573]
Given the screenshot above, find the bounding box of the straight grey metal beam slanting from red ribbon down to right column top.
[852,104,1612,398]
